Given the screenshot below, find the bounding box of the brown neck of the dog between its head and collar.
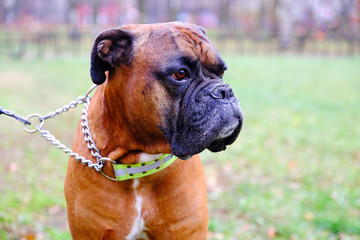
[88,79,171,164]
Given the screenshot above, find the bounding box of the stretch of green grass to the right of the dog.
[205,56,360,239]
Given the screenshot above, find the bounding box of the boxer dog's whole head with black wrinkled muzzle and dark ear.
[91,23,243,159]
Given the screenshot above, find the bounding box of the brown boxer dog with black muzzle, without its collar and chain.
[65,22,243,240]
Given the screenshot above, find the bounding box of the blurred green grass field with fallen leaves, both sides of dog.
[0,55,360,240]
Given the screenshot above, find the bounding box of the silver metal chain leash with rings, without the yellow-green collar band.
[0,85,108,172]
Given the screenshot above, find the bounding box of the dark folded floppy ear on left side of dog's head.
[90,28,133,85]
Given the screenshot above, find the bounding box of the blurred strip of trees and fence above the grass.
[0,0,360,57]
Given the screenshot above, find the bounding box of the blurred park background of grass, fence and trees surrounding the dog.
[0,0,360,240]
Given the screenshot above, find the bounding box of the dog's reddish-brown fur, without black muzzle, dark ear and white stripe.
[65,22,211,240]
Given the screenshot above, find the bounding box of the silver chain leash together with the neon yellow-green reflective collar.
[0,85,176,181]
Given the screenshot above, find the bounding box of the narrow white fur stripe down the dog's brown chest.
[126,179,148,240]
